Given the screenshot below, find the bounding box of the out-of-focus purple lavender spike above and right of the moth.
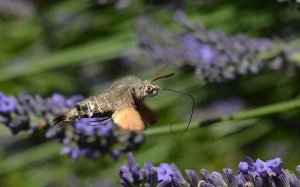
[137,11,300,82]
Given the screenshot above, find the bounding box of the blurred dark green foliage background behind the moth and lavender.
[0,0,300,187]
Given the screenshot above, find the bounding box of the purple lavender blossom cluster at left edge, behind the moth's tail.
[0,93,83,137]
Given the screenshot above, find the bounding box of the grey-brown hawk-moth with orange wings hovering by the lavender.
[53,65,174,131]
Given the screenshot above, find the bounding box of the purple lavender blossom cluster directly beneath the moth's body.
[61,118,144,160]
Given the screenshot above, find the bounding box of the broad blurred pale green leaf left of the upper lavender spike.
[0,34,135,81]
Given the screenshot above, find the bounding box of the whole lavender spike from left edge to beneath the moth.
[0,92,144,159]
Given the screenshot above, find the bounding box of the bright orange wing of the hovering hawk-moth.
[112,106,147,131]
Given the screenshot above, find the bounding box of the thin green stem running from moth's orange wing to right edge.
[146,99,300,135]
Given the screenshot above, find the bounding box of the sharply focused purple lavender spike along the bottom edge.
[119,153,300,187]
